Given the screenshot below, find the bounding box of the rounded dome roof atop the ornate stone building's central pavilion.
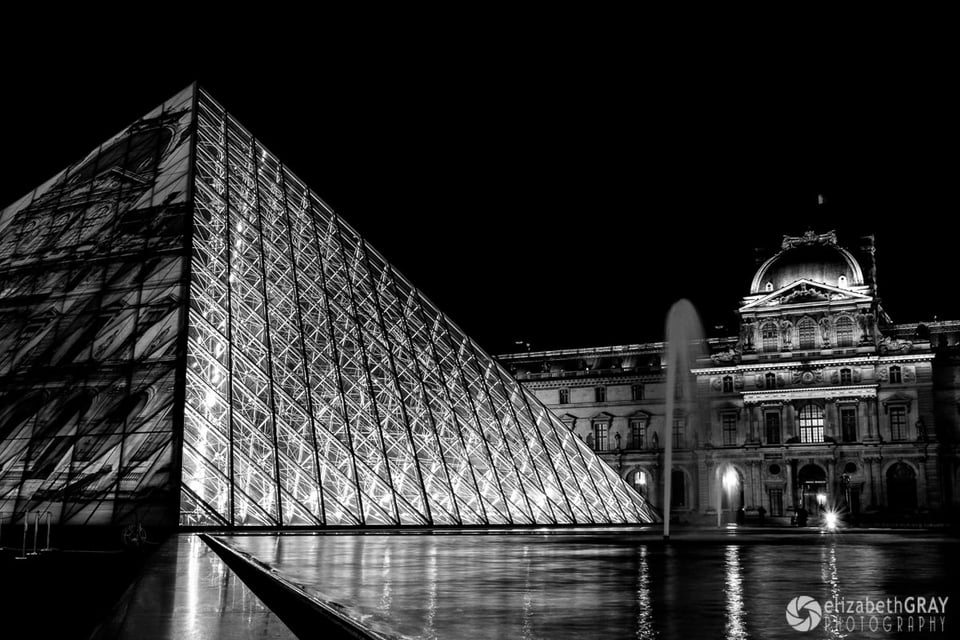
[750,231,863,294]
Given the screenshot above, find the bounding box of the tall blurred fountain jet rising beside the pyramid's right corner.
[663,298,703,540]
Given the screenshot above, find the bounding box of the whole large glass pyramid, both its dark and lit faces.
[0,84,651,526]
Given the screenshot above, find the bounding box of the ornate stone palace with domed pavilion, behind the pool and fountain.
[500,232,960,521]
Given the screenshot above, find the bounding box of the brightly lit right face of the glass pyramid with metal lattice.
[0,84,653,526]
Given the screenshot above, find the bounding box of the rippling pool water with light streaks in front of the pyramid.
[224,533,960,640]
